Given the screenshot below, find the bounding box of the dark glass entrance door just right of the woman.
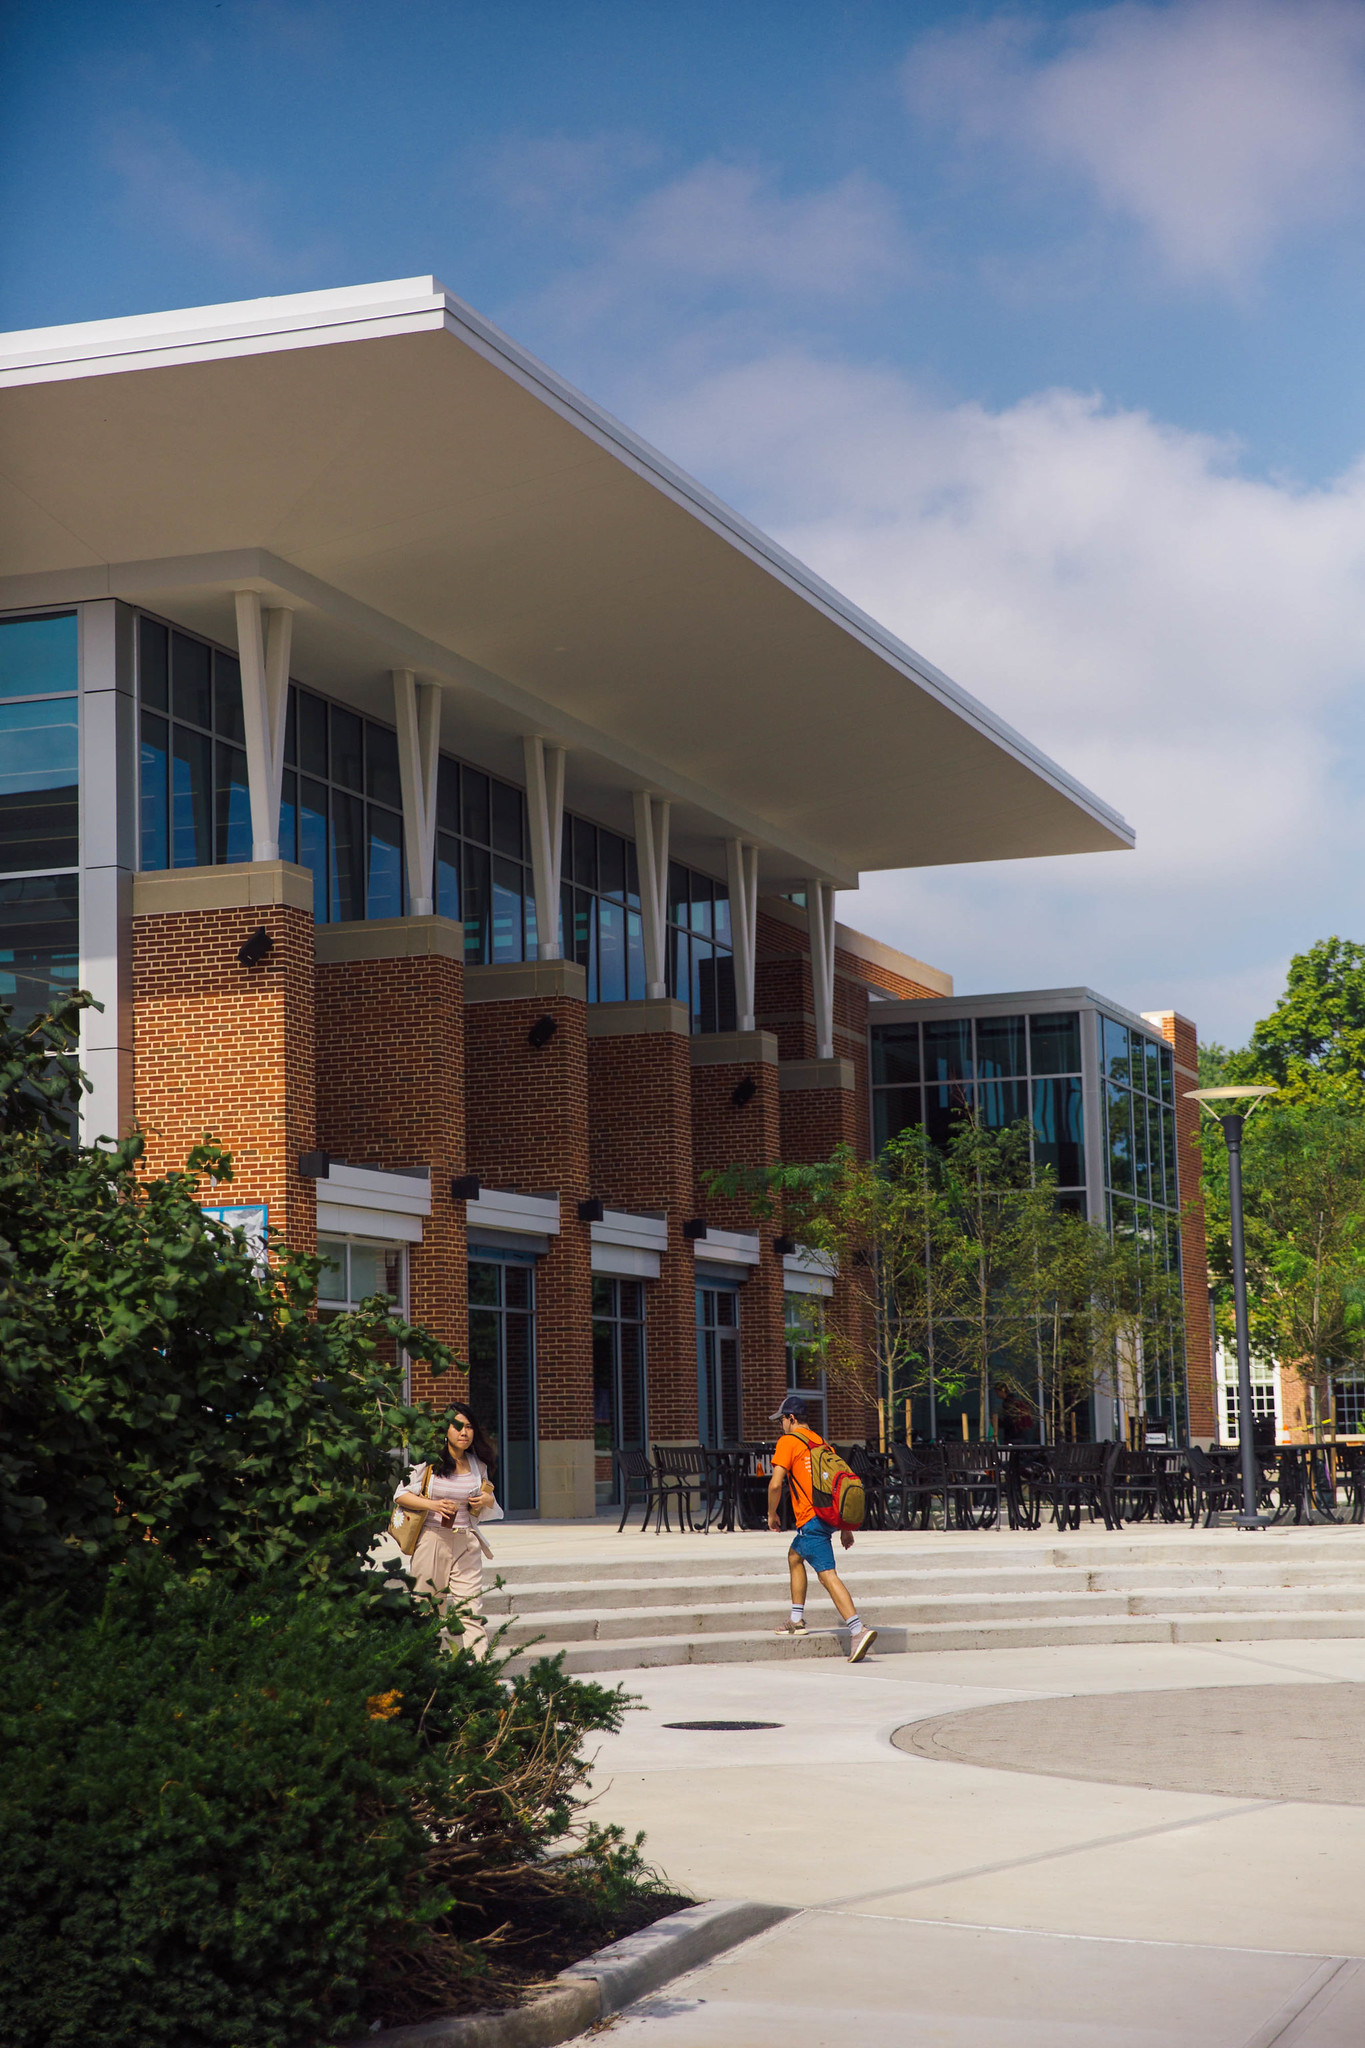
[469,1257,536,1511]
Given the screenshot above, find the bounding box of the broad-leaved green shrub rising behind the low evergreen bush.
[0,997,450,1583]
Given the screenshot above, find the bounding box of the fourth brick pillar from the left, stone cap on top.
[587,1001,700,1449]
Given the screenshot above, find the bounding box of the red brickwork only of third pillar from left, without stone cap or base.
[465,995,593,1442]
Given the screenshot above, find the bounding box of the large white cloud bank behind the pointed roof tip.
[643,354,1365,1038]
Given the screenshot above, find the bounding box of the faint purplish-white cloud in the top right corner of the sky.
[905,0,1365,285]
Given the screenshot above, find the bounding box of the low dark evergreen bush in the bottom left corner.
[0,1563,639,2048]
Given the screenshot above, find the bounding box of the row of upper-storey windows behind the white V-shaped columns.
[133,614,735,1030]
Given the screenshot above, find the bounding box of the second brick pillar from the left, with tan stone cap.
[315,918,469,1405]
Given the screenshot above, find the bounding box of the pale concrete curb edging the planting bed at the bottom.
[350,1898,796,2048]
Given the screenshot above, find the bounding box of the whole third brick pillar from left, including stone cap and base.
[465,961,598,1518]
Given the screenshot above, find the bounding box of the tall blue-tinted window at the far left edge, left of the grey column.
[0,612,80,1026]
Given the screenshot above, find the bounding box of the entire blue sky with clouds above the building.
[0,0,1365,1040]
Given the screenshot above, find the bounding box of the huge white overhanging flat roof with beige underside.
[0,279,1132,889]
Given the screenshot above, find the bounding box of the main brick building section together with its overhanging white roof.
[0,279,1211,1516]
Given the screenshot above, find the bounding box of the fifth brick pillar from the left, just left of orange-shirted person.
[692,1030,786,1440]
